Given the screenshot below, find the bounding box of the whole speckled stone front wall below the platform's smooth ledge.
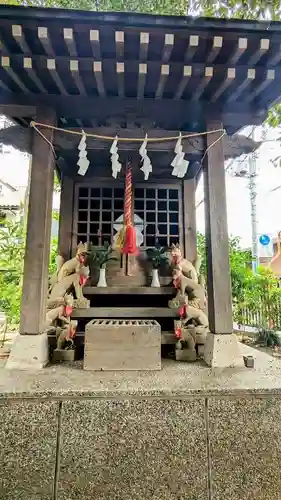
[0,392,281,500]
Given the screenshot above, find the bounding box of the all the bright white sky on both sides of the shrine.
[0,128,281,248]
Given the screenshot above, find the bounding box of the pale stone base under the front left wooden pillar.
[5,333,49,370]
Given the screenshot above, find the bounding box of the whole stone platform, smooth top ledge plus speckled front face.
[0,346,281,500]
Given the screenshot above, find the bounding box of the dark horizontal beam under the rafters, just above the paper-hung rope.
[0,91,264,133]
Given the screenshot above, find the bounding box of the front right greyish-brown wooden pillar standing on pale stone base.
[204,121,233,334]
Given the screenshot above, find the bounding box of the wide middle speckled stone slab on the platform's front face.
[58,399,208,500]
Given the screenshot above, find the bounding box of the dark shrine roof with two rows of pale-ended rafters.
[0,5,281,134]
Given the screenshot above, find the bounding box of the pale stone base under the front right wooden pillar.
[201,333,244,368]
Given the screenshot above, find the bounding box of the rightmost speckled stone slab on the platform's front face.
[208,397,281,500]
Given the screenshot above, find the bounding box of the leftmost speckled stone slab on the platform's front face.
[0,401,58,500]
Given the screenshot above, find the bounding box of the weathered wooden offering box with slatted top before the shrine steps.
[84,319,161,371]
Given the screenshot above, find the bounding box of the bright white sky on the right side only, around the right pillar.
[196,127,281,248]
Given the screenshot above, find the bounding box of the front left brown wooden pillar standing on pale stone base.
[20,108,56,335]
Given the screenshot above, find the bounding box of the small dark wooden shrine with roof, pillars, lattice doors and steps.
[0,6,281,365]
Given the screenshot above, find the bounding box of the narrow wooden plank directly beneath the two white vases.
[83,286,175,295]
